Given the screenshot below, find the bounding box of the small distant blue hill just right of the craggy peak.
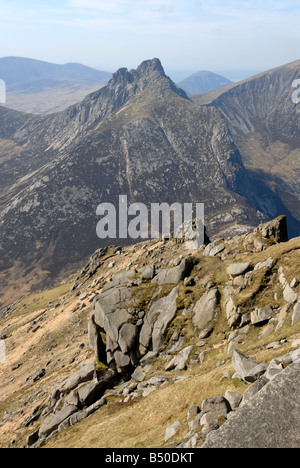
[177,71,232,96]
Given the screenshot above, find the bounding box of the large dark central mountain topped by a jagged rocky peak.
[0,59,286,305]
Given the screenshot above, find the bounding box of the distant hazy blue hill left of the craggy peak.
[0,57,111,114]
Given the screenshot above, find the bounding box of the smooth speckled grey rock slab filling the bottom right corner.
[203,364,300,448]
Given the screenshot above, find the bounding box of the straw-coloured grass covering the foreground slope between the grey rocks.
[0,239,300,448]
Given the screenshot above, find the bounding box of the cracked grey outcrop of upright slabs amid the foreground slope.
[89,265,180,373]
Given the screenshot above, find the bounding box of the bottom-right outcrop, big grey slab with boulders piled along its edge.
[180,349,300,448]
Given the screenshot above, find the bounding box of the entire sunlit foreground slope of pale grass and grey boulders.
[0,216,300,449]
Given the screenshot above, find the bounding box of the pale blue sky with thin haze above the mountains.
[0,0,300,79]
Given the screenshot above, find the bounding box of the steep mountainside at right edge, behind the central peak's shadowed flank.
[193,61,300,236]
